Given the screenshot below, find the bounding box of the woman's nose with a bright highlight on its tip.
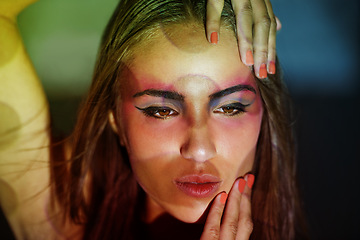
[180,126,216,162]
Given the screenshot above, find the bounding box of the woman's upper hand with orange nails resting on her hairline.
[206,0,281,78]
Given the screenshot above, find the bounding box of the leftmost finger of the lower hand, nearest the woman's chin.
[200,192,227,240]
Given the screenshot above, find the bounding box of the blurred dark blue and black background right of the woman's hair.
[272,0,360,239]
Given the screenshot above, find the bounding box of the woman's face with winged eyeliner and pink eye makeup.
[118,23,263,222]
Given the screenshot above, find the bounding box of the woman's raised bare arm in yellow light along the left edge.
[0,0,54,239]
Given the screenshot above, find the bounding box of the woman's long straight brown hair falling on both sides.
[53,0,304,239]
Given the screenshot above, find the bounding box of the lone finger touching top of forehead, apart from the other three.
[206,0,224,44]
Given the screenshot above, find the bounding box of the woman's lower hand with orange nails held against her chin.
[200,174,254,240]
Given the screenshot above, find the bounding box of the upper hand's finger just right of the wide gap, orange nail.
[232,0,254,66]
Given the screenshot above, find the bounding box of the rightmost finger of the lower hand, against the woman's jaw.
[236,174,255,240]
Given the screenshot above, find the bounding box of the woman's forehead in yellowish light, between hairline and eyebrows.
[126,25,255,94]
